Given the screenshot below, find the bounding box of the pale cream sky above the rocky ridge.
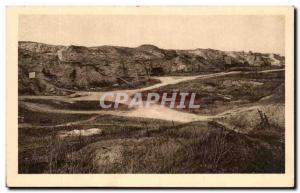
[19,15,285,55]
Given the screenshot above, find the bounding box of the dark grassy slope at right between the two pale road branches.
[153,71,284,114]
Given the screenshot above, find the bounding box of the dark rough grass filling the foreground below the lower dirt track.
[19,108,284,173]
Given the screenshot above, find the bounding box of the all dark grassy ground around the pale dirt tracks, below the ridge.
[18,69,285,173]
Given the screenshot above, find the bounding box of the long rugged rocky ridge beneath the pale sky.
[18,42,285,95]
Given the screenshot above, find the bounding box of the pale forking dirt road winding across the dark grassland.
[19,69,284,123]
